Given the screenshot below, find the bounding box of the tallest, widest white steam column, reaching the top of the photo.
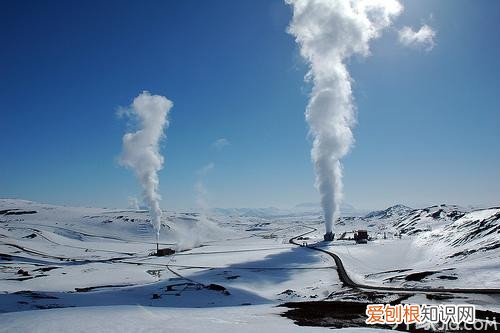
[285,0,402,232]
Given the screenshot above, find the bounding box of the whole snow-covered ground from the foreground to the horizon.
[0,199,500,332]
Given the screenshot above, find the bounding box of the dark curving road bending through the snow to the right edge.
[289,225,500,295]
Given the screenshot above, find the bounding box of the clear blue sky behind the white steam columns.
[0,0,500,208]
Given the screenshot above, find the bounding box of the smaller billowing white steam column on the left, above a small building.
[120,91,173,240]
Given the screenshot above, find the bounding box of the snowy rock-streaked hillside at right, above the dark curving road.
[336,204,500,286]
